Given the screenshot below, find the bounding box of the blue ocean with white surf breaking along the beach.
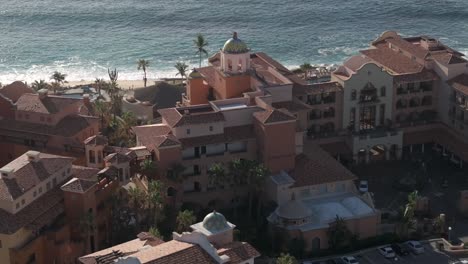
[0,0,468,83]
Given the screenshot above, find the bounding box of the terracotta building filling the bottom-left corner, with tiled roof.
[0,151,118,264]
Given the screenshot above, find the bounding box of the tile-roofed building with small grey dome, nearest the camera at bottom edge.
[79,212,260,264]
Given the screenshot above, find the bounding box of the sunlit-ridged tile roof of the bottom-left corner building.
[0,153,73,201]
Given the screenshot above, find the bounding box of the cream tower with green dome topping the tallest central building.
[221,32,250,73]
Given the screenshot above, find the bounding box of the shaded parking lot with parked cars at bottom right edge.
[302,242,458,264]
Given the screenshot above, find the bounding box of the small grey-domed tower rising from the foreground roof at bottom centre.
[191,211,236,246]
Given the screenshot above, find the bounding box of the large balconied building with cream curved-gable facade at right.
[294,31,468,165]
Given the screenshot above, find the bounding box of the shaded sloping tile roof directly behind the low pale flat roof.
[290,146,357,187]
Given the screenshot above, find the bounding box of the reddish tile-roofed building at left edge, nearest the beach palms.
[0,88,99,165]
